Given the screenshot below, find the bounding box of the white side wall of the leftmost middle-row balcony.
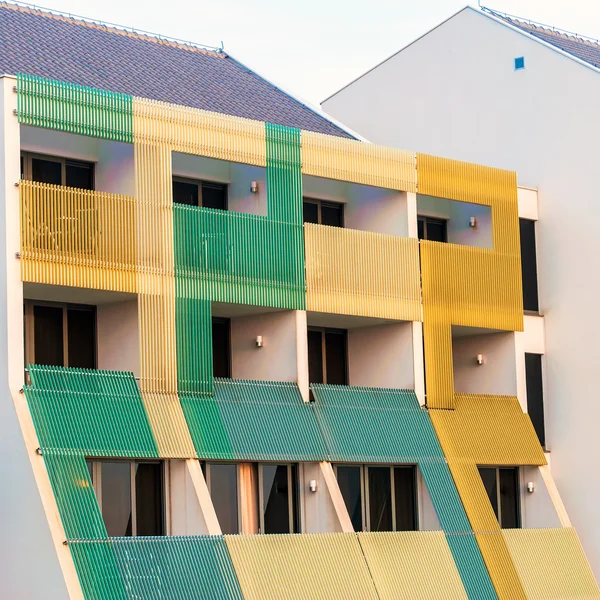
[96,300,140,377]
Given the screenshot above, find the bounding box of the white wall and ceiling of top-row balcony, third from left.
[302,175,409,236]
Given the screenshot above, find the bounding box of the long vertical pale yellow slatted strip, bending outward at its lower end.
[134,143,196,458]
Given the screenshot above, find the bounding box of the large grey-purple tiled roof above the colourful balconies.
[0,3,351,137]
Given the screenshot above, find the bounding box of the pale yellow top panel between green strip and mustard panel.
[300,131,417,192]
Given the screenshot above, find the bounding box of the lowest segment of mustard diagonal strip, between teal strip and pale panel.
[475,531,527,600]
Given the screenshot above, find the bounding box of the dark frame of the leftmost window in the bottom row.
[86,457,164,537]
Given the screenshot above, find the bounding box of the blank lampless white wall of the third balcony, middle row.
[348,322,415,389]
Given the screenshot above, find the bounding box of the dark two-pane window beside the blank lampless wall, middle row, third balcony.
[308,327,348,385]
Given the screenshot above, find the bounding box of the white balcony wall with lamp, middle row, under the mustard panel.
[452,331,517,396]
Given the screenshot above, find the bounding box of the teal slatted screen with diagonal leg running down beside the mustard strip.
[311,384,496,600]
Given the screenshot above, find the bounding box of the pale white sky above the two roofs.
[18,0,600,106]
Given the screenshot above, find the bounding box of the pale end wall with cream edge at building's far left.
[0,77,83,600]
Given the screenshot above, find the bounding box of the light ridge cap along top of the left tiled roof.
[0,0,227,58]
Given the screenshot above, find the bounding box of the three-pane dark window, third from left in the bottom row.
[334,465,417,531]
